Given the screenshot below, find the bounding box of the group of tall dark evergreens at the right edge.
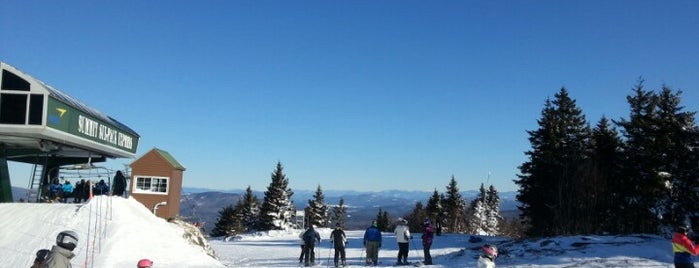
[515,80,699,236]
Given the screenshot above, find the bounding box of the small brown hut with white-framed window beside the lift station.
[129,148,185,219]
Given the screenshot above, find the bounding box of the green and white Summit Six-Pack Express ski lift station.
[0,62,140,202]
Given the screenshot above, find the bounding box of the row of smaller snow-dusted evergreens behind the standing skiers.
[211,162,502,237]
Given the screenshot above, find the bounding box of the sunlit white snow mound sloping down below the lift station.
[0,196,224,268]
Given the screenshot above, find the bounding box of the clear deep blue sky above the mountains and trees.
[0,1,699,191]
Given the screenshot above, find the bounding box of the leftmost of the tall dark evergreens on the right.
[515,88,590,236]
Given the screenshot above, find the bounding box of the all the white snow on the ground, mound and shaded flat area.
[0,196,673,268]
